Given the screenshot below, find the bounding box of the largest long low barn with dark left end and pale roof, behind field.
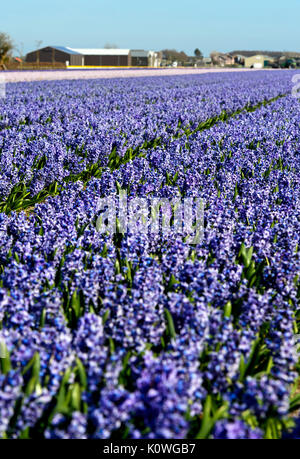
[26,46,131,67]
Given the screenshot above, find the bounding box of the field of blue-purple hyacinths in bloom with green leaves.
[0,71,300,439]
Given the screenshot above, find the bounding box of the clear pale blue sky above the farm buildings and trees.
[0,0,300,55]
